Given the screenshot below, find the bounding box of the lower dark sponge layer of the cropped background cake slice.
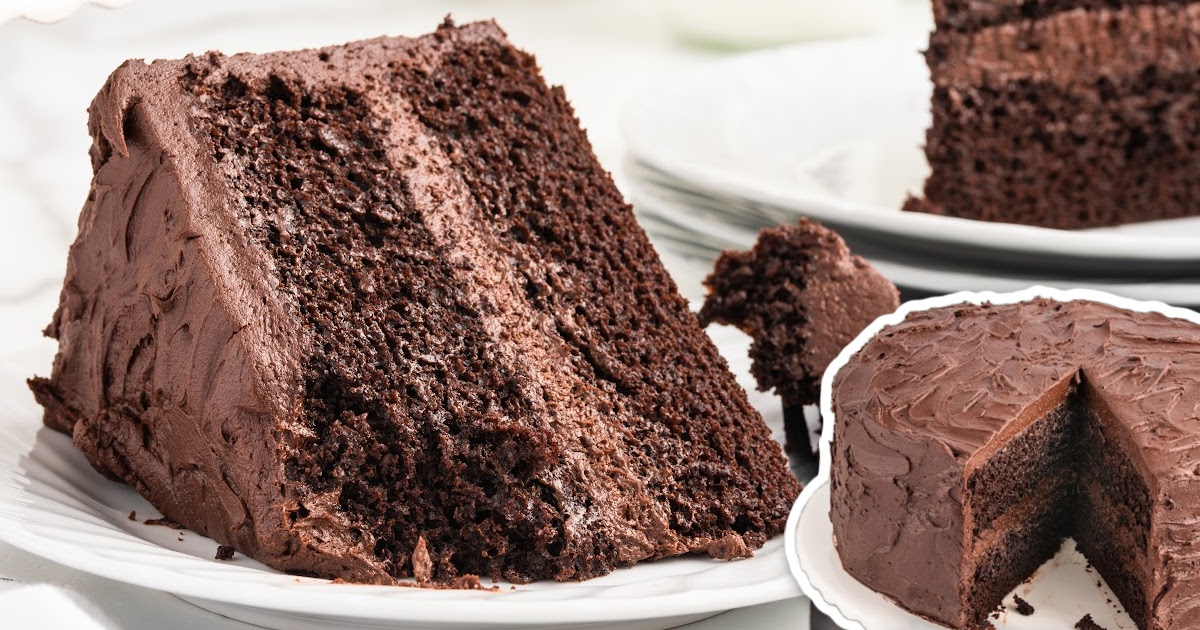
[905,66,1200,229]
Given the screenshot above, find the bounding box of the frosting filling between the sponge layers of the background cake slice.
[928,2,1200,92]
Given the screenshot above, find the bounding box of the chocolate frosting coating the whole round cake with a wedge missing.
[832,299,1200,629]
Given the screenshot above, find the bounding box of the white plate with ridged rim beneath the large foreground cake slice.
[0,328,800,629]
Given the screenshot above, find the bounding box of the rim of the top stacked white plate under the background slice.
[619,35,1200,265]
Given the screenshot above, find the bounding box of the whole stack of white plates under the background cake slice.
[623,37,1200,306]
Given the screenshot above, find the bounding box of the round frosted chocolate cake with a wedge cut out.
[830,298,1200,630]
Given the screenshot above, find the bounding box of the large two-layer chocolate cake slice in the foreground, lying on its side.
[23,23,798,583]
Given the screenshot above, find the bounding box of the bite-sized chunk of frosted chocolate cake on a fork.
[700,218,900,451]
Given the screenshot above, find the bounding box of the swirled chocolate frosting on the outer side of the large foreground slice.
[31,48,390,581]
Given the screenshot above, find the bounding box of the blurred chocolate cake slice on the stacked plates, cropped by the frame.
[905,0,1200,228]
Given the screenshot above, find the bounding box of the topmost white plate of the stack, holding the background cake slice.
[623,38,1200,270]
